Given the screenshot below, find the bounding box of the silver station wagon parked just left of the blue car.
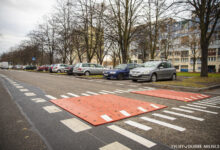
[73,63,106,76]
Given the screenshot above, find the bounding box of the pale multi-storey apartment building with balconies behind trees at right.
[130,18,220,72]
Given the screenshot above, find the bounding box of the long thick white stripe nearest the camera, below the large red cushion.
[108,125,156,148]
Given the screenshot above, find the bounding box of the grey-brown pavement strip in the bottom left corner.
[0,81,47,150]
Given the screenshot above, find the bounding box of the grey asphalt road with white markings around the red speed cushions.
[0,70,220,150]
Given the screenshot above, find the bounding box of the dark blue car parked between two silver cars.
[103,64,140,80]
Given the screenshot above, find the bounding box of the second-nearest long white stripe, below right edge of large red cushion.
[141,117,186,132]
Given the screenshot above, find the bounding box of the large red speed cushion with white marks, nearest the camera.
[51,94,166,126]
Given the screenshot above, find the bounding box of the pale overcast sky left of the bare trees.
[0,0,56,54]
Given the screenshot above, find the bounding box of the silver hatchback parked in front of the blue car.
[130,61,176,82]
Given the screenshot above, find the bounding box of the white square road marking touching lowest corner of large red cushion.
[60,118,91,132]
